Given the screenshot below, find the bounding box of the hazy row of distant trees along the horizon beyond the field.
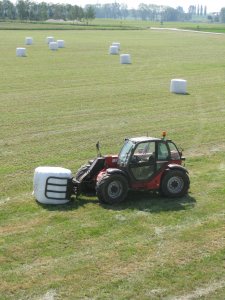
[0,0,225,22]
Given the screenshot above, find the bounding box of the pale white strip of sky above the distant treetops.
[34,0,225,13]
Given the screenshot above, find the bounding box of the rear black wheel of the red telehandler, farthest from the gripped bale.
[161,170,190,197]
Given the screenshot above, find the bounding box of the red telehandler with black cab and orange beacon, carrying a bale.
[72,132,190,204]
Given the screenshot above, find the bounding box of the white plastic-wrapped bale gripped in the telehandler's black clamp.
[33,167,72,204]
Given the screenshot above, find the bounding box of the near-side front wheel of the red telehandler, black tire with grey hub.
[96,173,128,204]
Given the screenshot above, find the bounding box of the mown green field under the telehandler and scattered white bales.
[0,24,225,300]
